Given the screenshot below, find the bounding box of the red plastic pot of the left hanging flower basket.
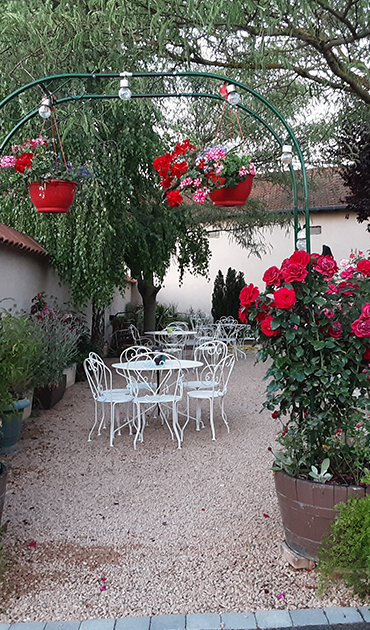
[28,179,77,212]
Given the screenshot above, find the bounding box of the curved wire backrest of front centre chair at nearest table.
[123,352,183,398]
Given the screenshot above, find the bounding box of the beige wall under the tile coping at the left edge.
[0,244,69,311]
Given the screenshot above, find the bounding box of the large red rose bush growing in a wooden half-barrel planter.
[239,251,370,560]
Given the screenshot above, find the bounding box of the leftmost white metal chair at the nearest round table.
[83,352,133,446]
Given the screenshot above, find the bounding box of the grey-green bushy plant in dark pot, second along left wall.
[31,293,84,409]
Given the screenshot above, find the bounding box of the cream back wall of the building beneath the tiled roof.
[158,211,370,313]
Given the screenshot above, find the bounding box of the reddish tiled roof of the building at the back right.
[250,168,350,210]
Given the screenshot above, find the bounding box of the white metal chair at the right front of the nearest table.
[181,354,235,440]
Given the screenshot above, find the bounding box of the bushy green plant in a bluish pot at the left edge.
[0,309,40,453]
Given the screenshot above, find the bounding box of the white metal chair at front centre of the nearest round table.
[124,351,183,449]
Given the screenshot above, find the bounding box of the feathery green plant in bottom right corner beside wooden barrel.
[318,496,370,597]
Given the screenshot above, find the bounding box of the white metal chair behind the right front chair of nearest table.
[184,340,228,389]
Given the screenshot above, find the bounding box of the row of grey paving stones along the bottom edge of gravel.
[0,606,370,630]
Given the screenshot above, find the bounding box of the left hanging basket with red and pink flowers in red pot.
[0,136,92,213]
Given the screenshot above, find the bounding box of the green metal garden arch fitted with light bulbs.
[0,71,311,252]
